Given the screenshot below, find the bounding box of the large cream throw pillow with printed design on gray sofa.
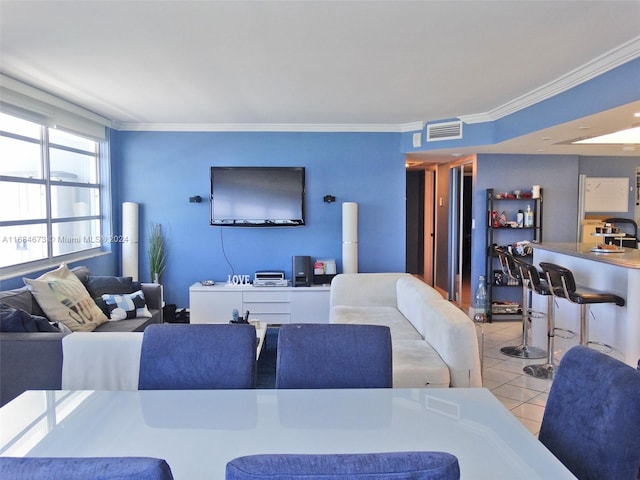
[24,263,108,332]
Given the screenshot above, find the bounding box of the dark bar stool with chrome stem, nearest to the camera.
[540,262,625,353]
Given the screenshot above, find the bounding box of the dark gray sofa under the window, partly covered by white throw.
[0,267,163,405]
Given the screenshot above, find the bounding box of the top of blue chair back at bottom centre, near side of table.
[225,452,460,480]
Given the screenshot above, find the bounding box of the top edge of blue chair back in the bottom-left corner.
[0,457,173,480]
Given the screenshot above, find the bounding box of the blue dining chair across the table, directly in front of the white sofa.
[276,324,393,388]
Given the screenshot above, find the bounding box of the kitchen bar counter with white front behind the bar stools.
[533,243,640,367]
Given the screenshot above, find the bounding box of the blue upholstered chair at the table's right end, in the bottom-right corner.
[538,346,640,480]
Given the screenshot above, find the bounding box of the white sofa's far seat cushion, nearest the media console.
[330,306,422,341]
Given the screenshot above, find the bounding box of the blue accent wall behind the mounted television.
[112,131,406,307]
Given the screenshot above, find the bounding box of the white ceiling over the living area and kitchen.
[0,0,640,160]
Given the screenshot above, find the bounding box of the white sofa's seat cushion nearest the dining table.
[392,340,451,388]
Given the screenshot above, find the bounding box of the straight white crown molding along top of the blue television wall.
[113,122,424,133]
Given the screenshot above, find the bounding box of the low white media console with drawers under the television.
[189,282,330,324]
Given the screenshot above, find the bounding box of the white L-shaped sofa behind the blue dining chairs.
[330,273,482,388]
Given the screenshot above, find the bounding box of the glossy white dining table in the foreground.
[0,388,575,480]
